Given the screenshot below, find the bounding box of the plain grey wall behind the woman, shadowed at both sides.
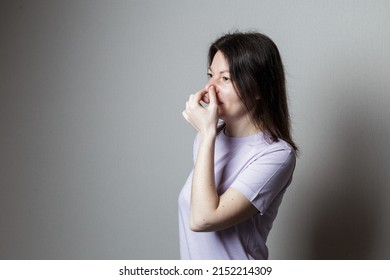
[0,0,390,259]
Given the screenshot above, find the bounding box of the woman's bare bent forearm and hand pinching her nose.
[183,87,257,231]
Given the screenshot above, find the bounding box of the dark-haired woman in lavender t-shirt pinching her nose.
[179,33,297,259]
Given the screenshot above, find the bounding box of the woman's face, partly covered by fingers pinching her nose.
[205,51,246,123]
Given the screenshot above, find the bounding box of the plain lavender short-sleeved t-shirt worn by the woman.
[179,132,295,260]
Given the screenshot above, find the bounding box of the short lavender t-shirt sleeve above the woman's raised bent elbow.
[231,147,295,214]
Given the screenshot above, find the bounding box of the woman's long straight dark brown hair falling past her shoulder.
[208,32,298,151]
